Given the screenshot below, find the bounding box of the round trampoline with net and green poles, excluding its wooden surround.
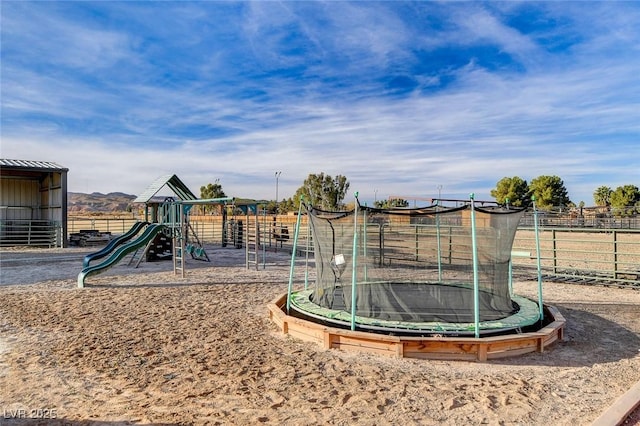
[286,195,556,337]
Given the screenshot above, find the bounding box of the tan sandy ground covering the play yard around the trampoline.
[0,248,640,425]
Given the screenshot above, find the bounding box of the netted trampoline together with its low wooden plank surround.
[269,196,564,361]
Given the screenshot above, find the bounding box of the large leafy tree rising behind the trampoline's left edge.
[293,173,349,211]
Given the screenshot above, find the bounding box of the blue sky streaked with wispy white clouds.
[0,1,640,205]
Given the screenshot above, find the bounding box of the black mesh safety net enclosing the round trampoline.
[304,203,524,323]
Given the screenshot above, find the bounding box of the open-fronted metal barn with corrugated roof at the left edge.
[0,159,69,247]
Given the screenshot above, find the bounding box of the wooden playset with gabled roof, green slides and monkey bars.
[78,175,276,288]
